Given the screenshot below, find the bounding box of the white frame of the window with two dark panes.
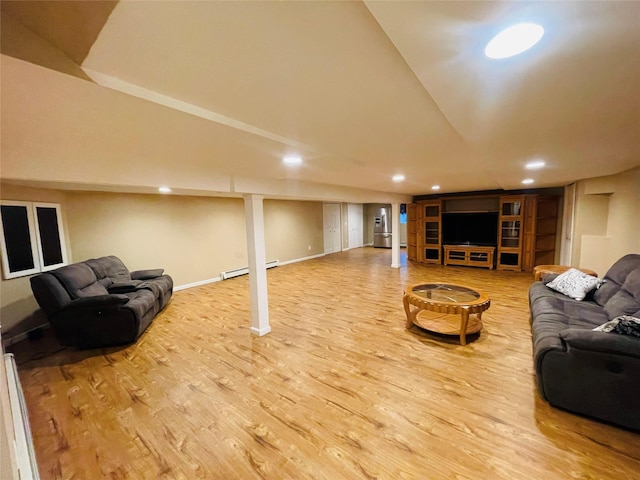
[0,200,68,280]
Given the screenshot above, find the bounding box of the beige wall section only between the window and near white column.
[64,193,247,285]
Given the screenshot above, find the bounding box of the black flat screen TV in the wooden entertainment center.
[442,212,498,247]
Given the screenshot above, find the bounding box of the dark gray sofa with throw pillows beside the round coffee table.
[529,254,640,430]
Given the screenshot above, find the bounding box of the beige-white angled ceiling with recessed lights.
[1,1,640,200]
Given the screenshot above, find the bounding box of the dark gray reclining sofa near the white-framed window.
[30,256,173,348]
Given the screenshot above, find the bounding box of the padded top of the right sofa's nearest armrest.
[560,328,640,358]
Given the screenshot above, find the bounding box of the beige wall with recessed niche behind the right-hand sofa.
[572,167,640,275]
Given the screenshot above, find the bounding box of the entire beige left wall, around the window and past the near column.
[0,185,323,334]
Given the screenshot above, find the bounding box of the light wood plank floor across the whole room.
[7,248,640,480]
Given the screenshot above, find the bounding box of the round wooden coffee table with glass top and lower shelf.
[402,283,491,345]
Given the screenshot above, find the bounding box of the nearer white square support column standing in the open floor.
[242,195,271,336]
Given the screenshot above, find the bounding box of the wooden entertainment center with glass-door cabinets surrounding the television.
[407,193,560,271]
